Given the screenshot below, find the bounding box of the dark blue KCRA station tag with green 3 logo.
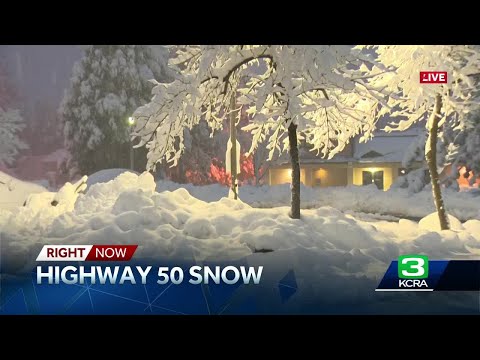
[376,255,480,291]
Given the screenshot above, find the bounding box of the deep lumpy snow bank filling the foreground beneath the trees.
[0,172,480,308]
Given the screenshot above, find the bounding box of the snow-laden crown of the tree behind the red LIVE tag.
[370,45,480,131]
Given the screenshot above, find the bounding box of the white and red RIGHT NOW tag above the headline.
[37,245,138,261]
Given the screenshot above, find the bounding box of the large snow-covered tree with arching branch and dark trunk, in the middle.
[134,45,388,218]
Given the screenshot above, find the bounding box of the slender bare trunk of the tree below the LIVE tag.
[425,95,450,230]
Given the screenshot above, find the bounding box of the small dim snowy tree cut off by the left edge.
[0,107,28,165]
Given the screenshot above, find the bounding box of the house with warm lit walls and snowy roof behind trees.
[268,127,424,190]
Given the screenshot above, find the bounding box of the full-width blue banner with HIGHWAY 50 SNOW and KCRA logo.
[0,249,480,315]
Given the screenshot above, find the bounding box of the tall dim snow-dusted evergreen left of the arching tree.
[59,45,167,173]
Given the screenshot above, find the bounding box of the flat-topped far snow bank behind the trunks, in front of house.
[157,180,480,221]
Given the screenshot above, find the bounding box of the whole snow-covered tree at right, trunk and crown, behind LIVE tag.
[370,45,480,230]
